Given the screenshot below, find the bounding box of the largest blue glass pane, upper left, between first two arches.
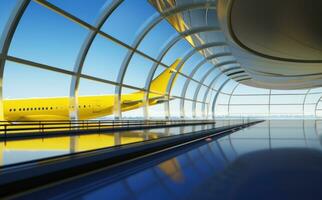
[9,2,88,70]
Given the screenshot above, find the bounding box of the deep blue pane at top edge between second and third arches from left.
[102,0,156,44]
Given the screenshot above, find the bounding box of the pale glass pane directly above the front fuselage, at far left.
[3,61,71,99]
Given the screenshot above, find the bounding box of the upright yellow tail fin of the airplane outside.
[150,58,182,94]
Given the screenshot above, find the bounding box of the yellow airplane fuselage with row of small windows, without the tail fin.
[4,93,157,121]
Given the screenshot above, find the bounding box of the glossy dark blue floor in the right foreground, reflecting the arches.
[19,120,322,199]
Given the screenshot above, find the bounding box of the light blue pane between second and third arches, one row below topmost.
[82,36,127,81]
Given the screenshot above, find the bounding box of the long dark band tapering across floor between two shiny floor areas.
[0,122,259,197]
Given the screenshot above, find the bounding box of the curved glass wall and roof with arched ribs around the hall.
[0,0,322,119]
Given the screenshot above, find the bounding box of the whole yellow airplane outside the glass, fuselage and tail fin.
[3,59,182,121]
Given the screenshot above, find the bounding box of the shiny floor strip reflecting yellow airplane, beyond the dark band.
[0,120,241,166]
